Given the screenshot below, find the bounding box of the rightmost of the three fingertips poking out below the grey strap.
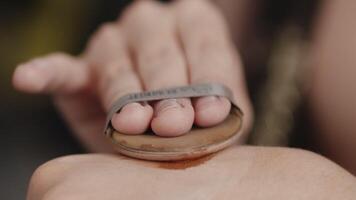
[194,96,231,127]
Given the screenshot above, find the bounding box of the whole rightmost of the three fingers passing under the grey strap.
[175,1,252,126]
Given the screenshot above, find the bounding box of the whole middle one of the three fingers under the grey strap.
[122,1,194,136]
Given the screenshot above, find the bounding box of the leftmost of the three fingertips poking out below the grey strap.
[111,103,153,135]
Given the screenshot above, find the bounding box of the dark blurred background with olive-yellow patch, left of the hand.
[0,0,129,200]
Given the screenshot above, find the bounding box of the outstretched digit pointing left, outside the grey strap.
[13,53,90,93]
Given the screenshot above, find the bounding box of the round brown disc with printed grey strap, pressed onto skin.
[105,84,243,161]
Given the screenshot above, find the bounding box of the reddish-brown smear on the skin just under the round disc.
[158,154,214,170]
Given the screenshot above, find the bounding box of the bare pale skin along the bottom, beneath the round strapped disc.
[28,146,356,200]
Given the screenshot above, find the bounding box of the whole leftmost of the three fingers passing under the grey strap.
[85,24,153,134]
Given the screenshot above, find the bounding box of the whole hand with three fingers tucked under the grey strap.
[13,0,252,151]
